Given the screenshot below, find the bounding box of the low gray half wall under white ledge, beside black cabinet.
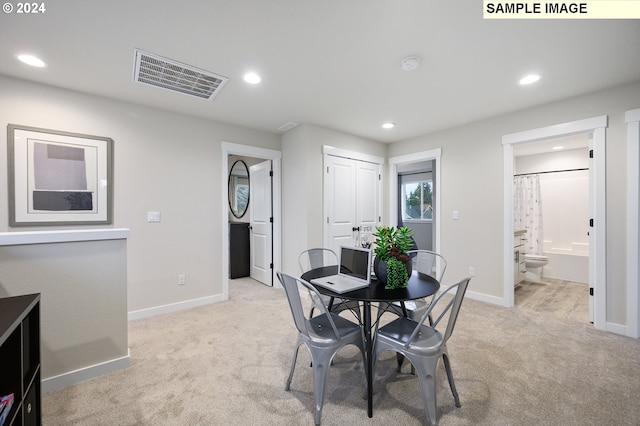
[0,239,128,391]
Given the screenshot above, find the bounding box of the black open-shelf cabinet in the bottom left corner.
[0,294,42,426]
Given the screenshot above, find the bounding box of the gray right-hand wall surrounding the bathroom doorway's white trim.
[388,82,640,324]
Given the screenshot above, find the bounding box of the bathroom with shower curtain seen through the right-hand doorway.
[513,133,591,323]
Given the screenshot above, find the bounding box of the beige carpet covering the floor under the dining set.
[42,279,640,426]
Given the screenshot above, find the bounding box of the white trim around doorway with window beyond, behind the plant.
[389,148,442,253]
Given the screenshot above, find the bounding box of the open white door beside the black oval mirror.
[249,160,273,285]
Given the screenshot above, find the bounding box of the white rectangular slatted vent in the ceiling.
[133,49,229,99]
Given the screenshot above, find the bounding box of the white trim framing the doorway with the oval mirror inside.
[220,142,282,300]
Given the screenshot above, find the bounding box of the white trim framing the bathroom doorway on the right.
[502,115,607,329]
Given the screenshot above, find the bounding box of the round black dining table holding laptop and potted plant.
[301,265,440,417]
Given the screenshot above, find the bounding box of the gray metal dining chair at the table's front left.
[277,272,366,425]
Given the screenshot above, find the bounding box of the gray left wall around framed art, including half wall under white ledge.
[0,76,280,386]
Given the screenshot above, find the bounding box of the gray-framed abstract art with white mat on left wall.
[7,124,113,226]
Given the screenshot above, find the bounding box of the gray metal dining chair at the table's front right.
[373,277,471,425]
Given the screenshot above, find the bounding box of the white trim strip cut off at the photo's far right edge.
[625,108,640,339]
